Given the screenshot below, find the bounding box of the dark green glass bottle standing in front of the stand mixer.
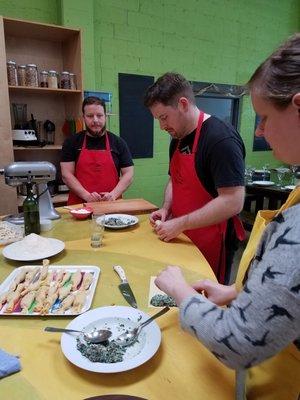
[23,183,41,235]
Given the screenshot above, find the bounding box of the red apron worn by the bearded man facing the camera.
[68,132,119,205]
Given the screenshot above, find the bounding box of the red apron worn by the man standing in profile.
[170,112,227,282]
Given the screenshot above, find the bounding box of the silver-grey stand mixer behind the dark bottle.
[0,161,60,224]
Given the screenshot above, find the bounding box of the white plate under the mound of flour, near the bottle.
[2,238,65,261]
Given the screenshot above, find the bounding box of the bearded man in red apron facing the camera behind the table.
[60,97,133,204]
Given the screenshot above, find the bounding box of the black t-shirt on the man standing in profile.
[170,116,245,197]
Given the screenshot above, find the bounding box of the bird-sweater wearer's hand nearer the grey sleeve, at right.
[192,279,238,306]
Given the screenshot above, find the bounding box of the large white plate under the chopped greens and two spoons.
[61,306,161,373]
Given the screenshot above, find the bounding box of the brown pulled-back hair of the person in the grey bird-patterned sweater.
[248,33,300,108]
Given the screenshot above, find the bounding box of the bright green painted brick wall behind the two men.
[0,0,300,204]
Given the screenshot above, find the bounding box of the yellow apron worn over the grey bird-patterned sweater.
[236,187,300,400]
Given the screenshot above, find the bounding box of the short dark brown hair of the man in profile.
[144,72,196,107]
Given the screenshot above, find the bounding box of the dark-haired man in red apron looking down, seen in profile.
[145,73,245,282]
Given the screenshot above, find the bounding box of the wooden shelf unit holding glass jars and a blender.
[0,16,83,214]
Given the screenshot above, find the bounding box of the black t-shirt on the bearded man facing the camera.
[61,131,133,174]
